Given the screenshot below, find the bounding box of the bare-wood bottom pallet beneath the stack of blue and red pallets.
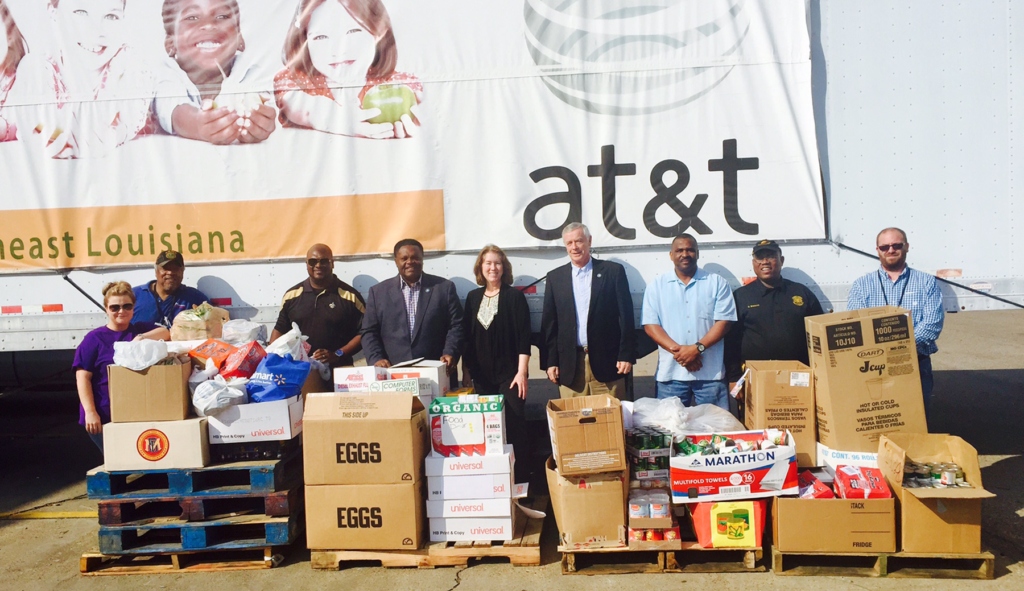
[79,548,282,577]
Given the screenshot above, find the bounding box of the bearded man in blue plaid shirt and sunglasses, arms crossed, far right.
[847,227,945,411]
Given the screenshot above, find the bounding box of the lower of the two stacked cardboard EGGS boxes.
[305,481,426,550]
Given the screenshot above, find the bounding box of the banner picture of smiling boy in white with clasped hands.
[155,0,276,144]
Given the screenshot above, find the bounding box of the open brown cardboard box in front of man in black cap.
[743,361,818,468]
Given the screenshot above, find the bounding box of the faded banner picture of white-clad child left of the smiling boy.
[8,0,153,159]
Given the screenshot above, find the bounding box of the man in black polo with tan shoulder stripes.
[270,244,366,368]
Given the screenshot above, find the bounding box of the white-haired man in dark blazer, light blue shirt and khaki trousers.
[541,222,636,398]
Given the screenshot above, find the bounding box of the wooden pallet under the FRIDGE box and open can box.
[772,548,995,579]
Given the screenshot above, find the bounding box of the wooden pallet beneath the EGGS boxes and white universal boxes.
[310,496,548,571]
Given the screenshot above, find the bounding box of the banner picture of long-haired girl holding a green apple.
[274,0,423,139]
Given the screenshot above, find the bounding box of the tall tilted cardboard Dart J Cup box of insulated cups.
[804,306,928,452]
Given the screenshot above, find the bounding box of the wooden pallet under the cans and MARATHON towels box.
[558,541,765,575]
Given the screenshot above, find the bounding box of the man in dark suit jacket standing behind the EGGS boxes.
[359,239,463,373]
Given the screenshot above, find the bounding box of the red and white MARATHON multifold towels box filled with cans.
[669,431,800,503]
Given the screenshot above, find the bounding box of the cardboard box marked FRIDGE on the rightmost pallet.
[772,498,896,553]
